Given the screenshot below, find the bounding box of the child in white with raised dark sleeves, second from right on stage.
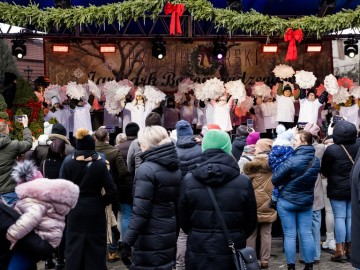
[298,89,328,124]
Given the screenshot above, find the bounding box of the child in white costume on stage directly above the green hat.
[211,96,234,132]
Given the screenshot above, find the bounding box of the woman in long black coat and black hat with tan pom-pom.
[60,128,117,270]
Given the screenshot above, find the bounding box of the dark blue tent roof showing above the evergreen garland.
[3,0,359,16]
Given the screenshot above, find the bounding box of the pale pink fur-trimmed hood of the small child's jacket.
[15,178,79,212]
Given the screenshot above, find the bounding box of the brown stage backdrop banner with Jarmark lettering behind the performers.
[44,38,332,93]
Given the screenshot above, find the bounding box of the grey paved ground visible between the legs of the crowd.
[38,238,354,270]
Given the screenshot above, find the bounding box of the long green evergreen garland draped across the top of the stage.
[0,0,360,38]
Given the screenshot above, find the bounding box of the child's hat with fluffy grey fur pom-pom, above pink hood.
[11,160,43,184]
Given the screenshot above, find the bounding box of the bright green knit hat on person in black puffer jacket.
[201,129,232,155]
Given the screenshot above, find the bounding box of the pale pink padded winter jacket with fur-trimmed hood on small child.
[6,178,79,248]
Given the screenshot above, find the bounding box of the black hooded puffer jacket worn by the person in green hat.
[179,149,257,270]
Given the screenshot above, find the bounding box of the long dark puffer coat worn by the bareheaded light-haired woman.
[123,143,181,270]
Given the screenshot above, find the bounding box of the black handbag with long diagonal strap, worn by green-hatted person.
[206,186,260,270]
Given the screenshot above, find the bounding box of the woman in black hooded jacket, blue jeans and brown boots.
[321,120,360,262]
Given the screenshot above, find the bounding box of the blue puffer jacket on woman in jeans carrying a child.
[272,145,320,207]
